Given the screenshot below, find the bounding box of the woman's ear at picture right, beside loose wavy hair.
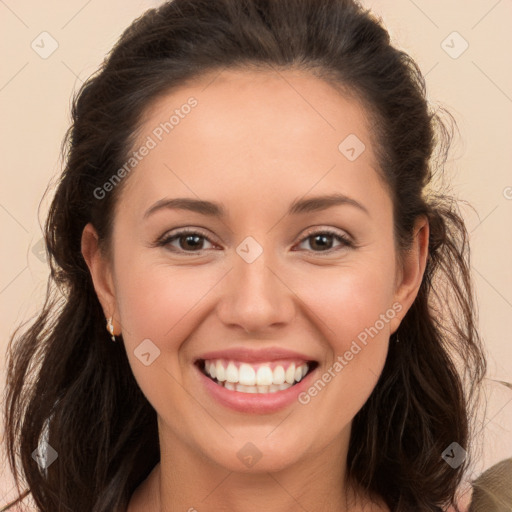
[390,216,430,333]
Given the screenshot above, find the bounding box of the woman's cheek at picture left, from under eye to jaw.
[116,258,219,411]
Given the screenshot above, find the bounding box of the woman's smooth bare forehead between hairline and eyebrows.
[117,70,388,218]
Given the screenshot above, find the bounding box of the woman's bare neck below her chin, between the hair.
[128,420,378,512]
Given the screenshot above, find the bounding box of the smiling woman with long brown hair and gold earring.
[1,0,486,512]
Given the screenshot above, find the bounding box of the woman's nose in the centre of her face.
[217,251,296,335]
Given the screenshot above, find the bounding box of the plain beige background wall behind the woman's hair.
[0,0,512,506]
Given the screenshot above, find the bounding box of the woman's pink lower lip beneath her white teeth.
[194,365,317,414]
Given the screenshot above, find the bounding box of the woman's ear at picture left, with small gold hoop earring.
[81,222,116,334]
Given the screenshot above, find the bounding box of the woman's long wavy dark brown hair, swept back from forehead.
[4,0,486,512]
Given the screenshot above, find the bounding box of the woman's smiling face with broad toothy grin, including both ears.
[83,70,428,471]
